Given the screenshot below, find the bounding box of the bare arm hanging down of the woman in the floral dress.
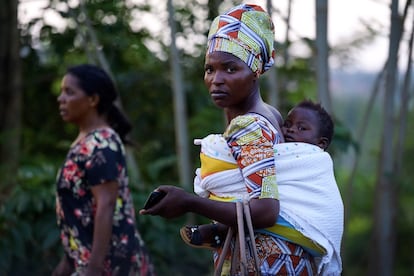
[85,181,118,275]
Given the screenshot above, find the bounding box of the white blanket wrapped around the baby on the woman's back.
[274,143,344,275]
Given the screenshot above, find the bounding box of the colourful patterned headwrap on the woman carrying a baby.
[207,4,275,74]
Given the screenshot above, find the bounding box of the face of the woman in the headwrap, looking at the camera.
[204,52,257,109]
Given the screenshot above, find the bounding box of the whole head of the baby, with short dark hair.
[282,100,334,150]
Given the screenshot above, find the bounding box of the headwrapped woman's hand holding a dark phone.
[139,185,194,219]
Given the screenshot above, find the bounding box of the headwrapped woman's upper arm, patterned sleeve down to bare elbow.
[224,114,280,228]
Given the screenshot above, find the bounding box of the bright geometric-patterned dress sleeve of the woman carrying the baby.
[224,115,279,199]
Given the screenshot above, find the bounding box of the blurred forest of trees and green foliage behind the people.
[0,0,414,275]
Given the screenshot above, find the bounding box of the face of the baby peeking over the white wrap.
[282,107,322,147]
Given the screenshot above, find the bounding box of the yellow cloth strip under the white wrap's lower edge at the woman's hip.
[265,224,326,255]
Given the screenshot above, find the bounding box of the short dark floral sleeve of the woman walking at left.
[85,133,124,186]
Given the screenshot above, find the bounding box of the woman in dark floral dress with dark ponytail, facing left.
[53,64,154,276]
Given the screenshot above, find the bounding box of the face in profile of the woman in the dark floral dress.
[57,74,96,125]
